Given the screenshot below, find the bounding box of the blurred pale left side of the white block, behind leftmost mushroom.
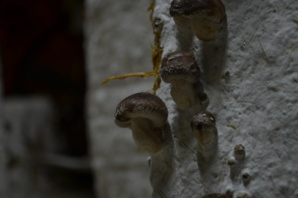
[85,0,153,198]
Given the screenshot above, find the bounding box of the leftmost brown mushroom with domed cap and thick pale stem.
[115,92,168,154]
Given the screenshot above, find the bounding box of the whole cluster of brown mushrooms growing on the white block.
[115,0,252,198]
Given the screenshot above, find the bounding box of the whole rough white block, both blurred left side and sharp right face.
[86,0,298,198]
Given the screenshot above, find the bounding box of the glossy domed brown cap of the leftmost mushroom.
[115,92,168,128]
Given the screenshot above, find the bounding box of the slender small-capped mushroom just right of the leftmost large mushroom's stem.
[191,112,218,160]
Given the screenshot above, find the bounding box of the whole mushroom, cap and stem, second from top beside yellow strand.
[160,52,207,110]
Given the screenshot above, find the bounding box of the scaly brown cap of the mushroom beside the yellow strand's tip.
[160,51,201,83]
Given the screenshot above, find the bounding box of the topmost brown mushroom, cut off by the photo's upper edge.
[170,0,226,41]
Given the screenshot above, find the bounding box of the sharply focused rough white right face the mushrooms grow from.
[154,0,298,198]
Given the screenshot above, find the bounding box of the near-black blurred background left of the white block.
[0,0,93,197]
